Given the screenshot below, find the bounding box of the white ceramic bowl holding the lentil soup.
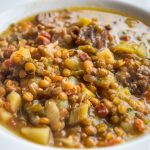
[0,0,150,150]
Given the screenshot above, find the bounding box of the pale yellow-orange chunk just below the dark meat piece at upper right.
[97,49,115,64]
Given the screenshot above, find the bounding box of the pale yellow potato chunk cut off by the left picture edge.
[0,108,12,122]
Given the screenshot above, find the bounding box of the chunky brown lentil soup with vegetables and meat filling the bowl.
[0,9,150,148]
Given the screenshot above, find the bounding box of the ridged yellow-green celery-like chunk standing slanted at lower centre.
[69,104,88,125]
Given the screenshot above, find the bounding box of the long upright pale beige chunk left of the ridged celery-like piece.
[45,101,61,130]
